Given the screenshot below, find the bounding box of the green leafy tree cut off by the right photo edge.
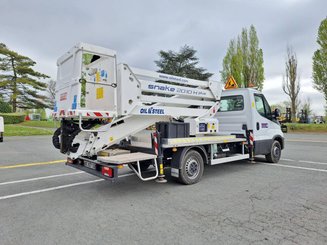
[312,18,327,114]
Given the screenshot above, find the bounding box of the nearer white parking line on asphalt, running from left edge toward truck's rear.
[0,173,135,200]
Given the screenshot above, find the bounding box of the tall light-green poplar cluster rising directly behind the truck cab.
[220,25,265,90]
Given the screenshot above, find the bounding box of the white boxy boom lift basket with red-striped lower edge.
[54,43,117,118]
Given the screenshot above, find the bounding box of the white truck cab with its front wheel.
[216,88,284,162]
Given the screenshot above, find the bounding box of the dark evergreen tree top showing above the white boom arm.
[155,45,213,80]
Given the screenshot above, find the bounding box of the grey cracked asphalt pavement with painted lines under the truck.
[0,134,327,244]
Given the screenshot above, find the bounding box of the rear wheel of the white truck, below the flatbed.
[178,150,204,185]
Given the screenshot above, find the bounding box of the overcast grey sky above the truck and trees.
[0,0,327,114]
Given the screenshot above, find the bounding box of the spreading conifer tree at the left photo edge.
[0,43,48,112]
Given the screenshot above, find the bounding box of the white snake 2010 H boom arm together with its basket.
[54,43,222,158]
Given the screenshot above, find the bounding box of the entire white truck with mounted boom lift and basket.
[53,43,284,184]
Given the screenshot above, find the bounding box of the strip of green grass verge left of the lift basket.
[4,124,53,137]
